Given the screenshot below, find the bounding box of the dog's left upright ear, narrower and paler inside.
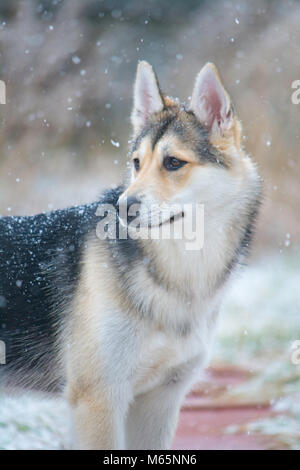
[131,61,164,134]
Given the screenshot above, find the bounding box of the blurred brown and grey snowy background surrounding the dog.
[0,0,300,448]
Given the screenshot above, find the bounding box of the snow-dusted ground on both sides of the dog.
[0,250,300,449]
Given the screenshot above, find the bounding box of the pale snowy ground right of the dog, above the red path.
[214,251,300,371]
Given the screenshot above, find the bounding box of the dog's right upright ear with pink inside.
[190,63,233,139]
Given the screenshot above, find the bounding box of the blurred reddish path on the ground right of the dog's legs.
[173,368,278,450]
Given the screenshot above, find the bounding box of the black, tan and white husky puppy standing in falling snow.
[0,62,261,449]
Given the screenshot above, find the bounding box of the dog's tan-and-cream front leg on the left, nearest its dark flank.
[66,309,138,449]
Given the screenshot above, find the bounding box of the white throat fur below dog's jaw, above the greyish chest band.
[143,211,239,298]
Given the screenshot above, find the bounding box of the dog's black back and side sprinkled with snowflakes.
[0,203,99,391]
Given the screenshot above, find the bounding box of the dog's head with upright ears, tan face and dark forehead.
[119,62,254,229]
